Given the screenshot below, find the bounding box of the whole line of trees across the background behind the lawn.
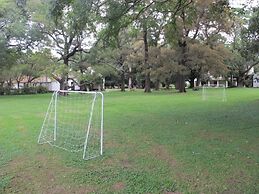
[0,0,259,92]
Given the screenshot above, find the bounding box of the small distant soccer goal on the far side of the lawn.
[202,84,227,102]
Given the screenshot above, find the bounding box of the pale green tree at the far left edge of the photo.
[0,0,43,86]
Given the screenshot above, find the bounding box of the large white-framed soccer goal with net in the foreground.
[38,90,104,160]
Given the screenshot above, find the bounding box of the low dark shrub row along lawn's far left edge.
[0,86,48,95]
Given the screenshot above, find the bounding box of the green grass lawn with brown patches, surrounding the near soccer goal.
[0,89,259,193]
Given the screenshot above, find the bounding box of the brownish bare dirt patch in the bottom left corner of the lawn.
[1,155,94,194]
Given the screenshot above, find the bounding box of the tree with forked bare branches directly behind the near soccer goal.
[38,0,101,89]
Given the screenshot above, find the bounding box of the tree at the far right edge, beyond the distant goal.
[229,5,259,87]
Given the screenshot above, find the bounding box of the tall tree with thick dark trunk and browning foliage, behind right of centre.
[166,0,233,92]
